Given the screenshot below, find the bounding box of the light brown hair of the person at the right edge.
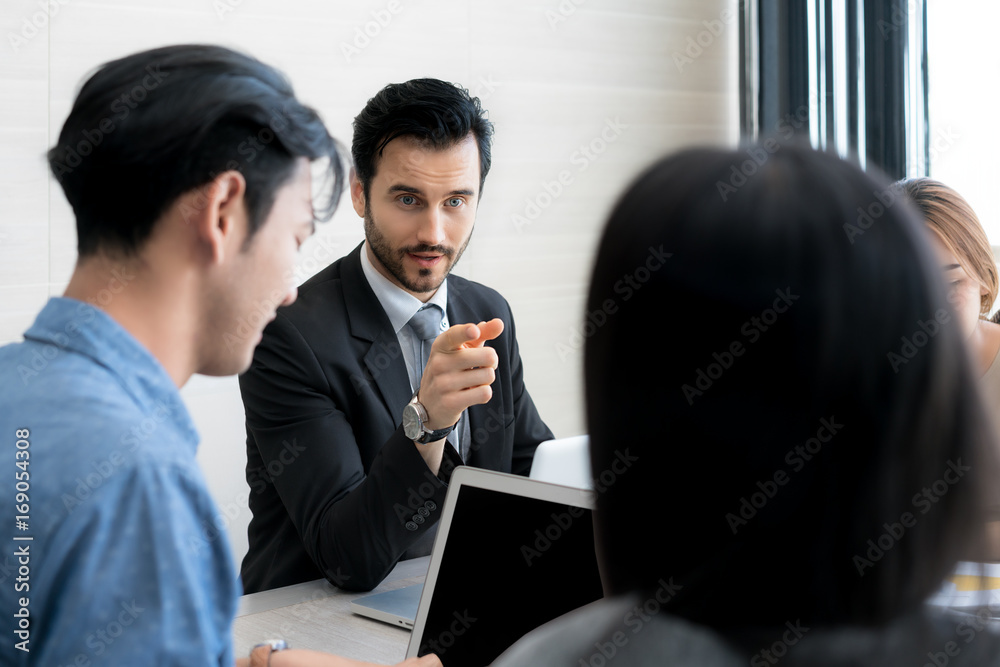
[896,178,1000,317]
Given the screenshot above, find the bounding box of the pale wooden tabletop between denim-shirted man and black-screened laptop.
[233,556,430,664]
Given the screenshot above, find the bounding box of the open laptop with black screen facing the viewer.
[406,466,604,667]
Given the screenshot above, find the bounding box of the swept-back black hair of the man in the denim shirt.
[48,45,345,256]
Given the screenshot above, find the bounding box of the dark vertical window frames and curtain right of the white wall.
[740,0,929,179]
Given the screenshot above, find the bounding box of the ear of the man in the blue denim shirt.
[183,170,249,264]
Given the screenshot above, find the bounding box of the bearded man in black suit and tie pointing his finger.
[240,79,552,593]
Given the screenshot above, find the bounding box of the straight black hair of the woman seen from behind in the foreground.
[585,144,995,628]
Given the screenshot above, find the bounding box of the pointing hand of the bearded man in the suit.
[418,319,503,430]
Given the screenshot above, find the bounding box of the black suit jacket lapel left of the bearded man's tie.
[341,243,410,424]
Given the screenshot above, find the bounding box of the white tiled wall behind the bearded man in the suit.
[0,0,737,558]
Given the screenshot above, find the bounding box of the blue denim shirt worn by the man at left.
[0,298,240,667]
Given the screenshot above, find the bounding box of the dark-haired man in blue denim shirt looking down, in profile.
[0,46,439,667]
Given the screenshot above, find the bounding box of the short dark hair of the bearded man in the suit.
[351,79,493,201]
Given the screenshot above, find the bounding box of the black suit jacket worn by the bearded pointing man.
[240,245,552,593]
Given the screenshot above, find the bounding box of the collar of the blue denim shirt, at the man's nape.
[24,297,198,446]
